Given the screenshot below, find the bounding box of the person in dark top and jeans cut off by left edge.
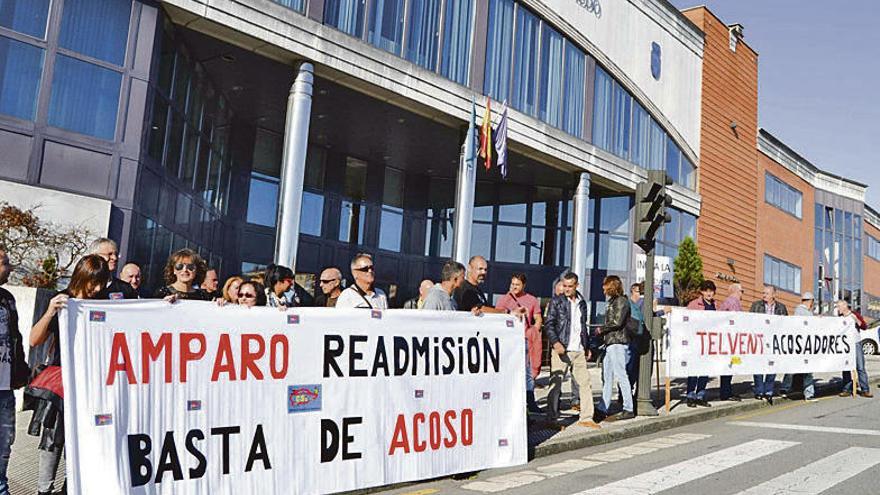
[0,246,30,495]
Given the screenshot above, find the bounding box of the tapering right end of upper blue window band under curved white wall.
[593,66,696,189]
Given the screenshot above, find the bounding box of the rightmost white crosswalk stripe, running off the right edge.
[739,447,880,495]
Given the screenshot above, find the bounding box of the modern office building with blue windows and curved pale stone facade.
[0,0,705,318]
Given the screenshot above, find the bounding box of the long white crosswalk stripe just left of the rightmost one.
[576,440,798,495]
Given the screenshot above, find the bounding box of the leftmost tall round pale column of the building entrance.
[275,62,314,271]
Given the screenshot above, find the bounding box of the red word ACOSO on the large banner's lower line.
[388,409,474,455]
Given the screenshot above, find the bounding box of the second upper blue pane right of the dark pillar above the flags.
[510,7,541,116]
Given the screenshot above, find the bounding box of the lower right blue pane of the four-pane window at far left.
[49,55,122,139]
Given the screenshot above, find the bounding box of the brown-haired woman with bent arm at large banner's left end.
[24,254,112,494]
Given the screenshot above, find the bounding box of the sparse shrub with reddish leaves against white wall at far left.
[0,201,95,289]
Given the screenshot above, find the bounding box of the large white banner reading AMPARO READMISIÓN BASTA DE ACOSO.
[61,300,527,495]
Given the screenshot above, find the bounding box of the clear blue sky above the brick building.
[671,0,880,209]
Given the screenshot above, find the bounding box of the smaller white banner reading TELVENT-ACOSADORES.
[666,308,859,377]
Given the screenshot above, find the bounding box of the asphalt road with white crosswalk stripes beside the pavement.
[382,396,880,495]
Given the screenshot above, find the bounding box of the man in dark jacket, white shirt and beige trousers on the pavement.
[544,272,599,428]
